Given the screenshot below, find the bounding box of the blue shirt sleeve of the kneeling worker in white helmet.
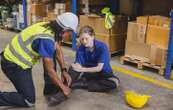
[32,38,56,58]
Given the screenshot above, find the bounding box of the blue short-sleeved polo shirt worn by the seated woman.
[75,40,112,73]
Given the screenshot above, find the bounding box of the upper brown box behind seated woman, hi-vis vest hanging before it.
[80,15,127,35]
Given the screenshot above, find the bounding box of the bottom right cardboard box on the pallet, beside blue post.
[150,45,167,66]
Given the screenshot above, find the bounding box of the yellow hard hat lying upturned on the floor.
[125,91,151,108]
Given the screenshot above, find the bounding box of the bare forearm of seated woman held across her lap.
[72,63,104,73]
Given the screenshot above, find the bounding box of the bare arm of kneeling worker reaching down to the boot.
[43,58,70,96]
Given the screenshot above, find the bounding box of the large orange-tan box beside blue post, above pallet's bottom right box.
[146,25,170,49]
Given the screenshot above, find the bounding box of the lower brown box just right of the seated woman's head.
[95,33,126,53]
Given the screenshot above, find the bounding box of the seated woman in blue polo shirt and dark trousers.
[68,26,120,92]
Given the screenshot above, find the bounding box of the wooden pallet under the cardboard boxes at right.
[120,56,165,76]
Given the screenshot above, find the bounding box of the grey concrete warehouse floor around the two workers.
[0,30,173,110]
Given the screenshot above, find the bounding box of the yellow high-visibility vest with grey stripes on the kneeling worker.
[4,22,55,69]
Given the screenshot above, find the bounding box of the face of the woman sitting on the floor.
[80,33,94,47]
